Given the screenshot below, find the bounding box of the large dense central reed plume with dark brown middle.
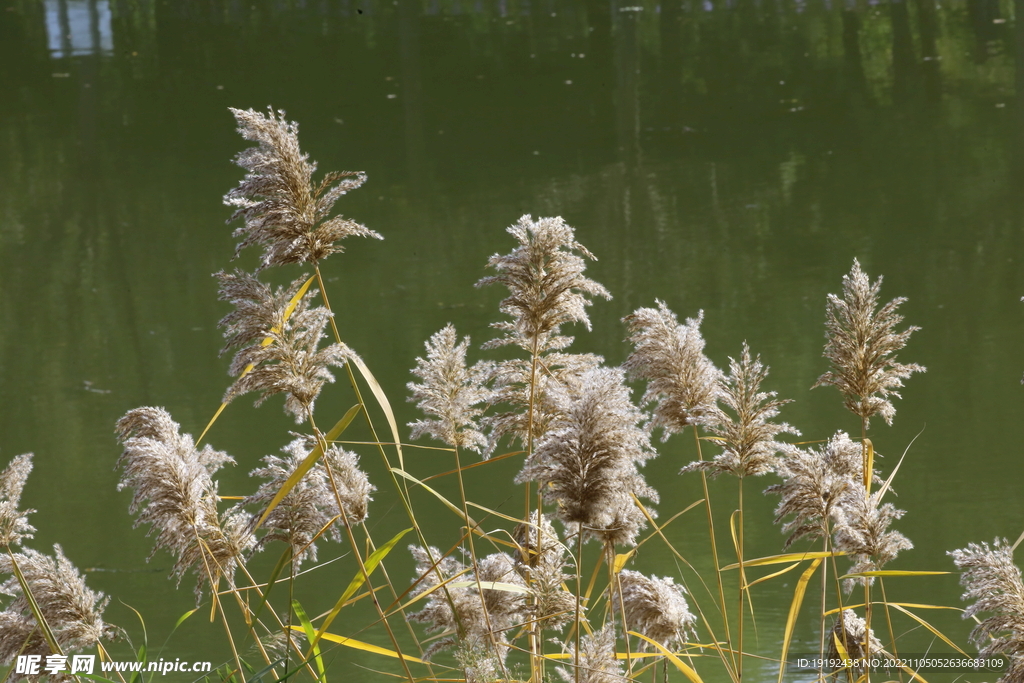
[516,368,657,545]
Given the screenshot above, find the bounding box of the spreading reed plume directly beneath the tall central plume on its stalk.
[480,351,603,458]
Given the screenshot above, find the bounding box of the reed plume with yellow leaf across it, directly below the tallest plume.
[216,270,352,423]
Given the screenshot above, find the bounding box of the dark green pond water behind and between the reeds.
[0,0,1024,680]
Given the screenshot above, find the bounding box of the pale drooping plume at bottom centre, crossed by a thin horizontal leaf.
[410,546,528,683]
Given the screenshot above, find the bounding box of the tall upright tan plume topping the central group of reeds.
[476,215,611,353]
